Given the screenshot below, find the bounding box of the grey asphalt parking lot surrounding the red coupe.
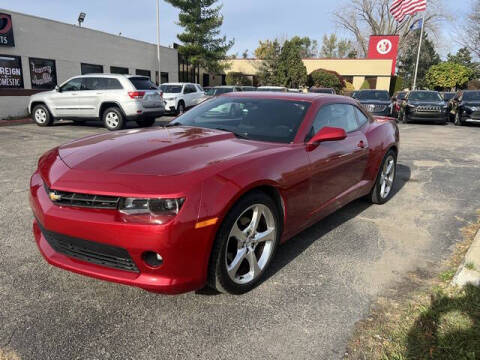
[0,122,480,359]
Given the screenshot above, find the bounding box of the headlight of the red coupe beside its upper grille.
[118,198,185,224]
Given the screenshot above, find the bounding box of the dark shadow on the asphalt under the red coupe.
[196,164,411,295]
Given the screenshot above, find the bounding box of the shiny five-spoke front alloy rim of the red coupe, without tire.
[225,204,277,284]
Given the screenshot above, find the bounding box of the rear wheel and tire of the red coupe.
[369,150,397,204]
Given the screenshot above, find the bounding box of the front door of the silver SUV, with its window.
[49,78,82,119]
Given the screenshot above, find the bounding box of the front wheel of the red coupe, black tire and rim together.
[208,191,280,294]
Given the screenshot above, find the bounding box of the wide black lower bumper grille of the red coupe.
[37,221,138,272]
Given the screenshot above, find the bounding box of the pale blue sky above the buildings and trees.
[0,0,472,56]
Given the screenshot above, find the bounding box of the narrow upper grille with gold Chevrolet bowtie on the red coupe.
[45,186,120,209]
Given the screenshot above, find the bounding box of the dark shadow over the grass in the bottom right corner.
[405,285,480,360]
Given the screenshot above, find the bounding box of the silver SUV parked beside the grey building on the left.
[28,74,165,130]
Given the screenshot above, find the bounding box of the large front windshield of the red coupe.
[173,97,310,143]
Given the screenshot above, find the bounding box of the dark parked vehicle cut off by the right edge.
[451,90,480,126]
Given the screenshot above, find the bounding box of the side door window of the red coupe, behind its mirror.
[312,104,358,134]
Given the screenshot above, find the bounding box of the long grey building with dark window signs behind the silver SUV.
[0,9,179,119]
